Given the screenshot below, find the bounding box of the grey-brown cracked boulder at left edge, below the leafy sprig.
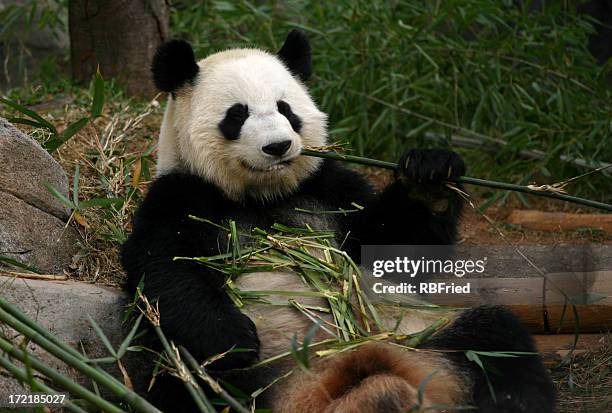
[0,118,78,274]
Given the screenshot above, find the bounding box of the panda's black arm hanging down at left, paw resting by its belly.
[121,174,259,369]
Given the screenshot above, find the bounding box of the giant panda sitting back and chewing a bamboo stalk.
[121,30,554,413]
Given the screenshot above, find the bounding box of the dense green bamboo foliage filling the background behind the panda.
[0,0,612,203]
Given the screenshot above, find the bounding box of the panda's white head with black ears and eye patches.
[152,30,327,200]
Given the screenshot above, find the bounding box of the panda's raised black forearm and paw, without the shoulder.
[344,149,465,259]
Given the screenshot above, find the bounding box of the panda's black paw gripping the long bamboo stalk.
[397,149,465,186]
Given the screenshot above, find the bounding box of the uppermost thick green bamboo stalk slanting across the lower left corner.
[0,298,161,413]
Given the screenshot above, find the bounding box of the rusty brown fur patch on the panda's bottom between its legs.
[274,343,470,413]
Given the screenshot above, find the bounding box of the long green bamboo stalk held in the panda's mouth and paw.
[302,149,612,211]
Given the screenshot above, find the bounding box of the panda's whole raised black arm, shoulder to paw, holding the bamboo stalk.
[310,149,465,258]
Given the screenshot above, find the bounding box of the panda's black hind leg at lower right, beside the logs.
[423,306,555,413]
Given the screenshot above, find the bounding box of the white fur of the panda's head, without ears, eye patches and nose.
[157,49,327,200]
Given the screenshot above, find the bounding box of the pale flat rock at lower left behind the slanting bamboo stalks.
[0,276,149,400]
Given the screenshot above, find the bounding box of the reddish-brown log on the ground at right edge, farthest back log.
[506,209,612,233]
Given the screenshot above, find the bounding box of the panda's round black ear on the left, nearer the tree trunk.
[151,40,200,93]
